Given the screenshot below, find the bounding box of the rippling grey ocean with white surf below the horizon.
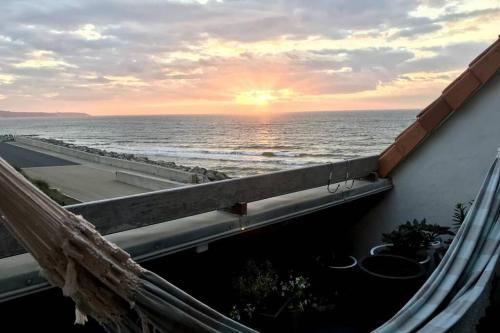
[0,110,417,177]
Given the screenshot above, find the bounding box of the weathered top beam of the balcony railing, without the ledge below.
[0,156,377,258]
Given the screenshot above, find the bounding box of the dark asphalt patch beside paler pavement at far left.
[0,142,78,168]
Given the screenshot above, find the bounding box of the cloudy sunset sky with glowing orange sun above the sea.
[0,0,500,115]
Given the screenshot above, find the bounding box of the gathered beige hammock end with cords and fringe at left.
[0,158,255,333]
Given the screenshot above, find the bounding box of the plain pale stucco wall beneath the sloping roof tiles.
[356,72,500,256]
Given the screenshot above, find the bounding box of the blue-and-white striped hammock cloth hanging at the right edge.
[374,149,500,333]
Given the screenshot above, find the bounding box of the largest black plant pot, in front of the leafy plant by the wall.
[358,255,425,329]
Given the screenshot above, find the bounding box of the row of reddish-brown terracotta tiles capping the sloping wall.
[378,38,500,177]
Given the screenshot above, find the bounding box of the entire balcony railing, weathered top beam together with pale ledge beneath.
[0,156,392,303]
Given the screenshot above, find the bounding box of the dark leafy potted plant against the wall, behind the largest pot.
[382,219,454,259]
